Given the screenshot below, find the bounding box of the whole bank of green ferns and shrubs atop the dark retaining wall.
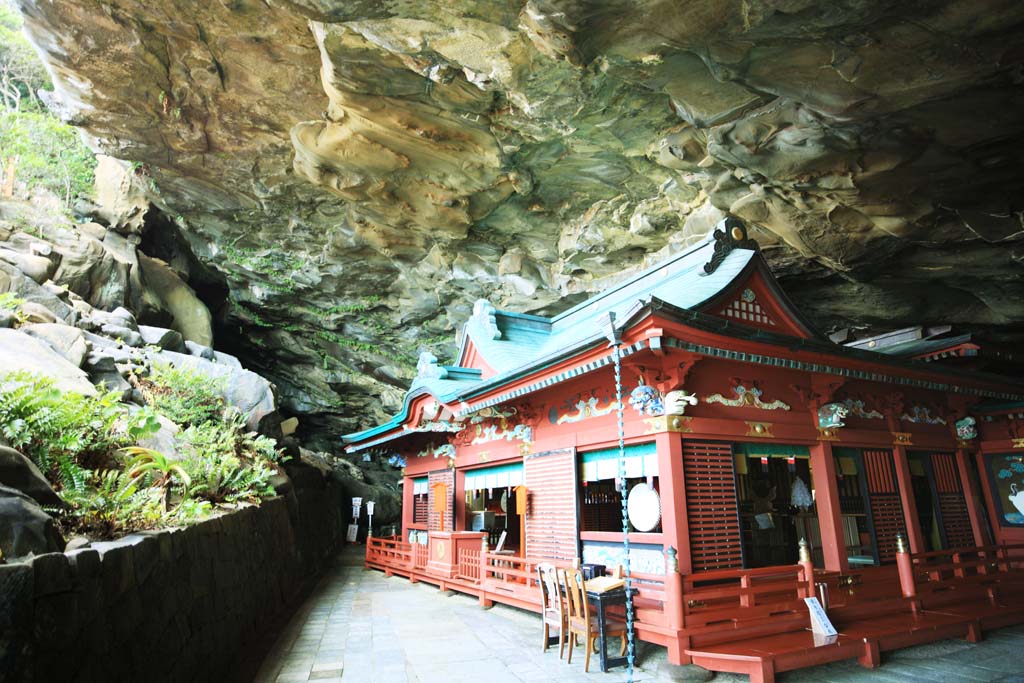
[0,367,283,538]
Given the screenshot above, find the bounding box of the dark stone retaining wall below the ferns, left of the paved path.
[0,471,348,683]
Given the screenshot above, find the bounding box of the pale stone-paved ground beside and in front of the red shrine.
[256,546,1024,683]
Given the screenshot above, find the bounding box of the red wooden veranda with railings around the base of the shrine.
[366,532,1024,682]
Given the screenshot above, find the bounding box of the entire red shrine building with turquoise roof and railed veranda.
[345,218,1024,680]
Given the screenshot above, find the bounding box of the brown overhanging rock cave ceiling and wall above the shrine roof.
[18,0,1024,445]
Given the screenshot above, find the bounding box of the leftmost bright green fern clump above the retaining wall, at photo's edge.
[0,372,128,485]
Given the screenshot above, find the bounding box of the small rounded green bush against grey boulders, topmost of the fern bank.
[138,364,224,426]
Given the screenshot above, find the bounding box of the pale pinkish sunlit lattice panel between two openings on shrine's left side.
[520,449,580,561]
